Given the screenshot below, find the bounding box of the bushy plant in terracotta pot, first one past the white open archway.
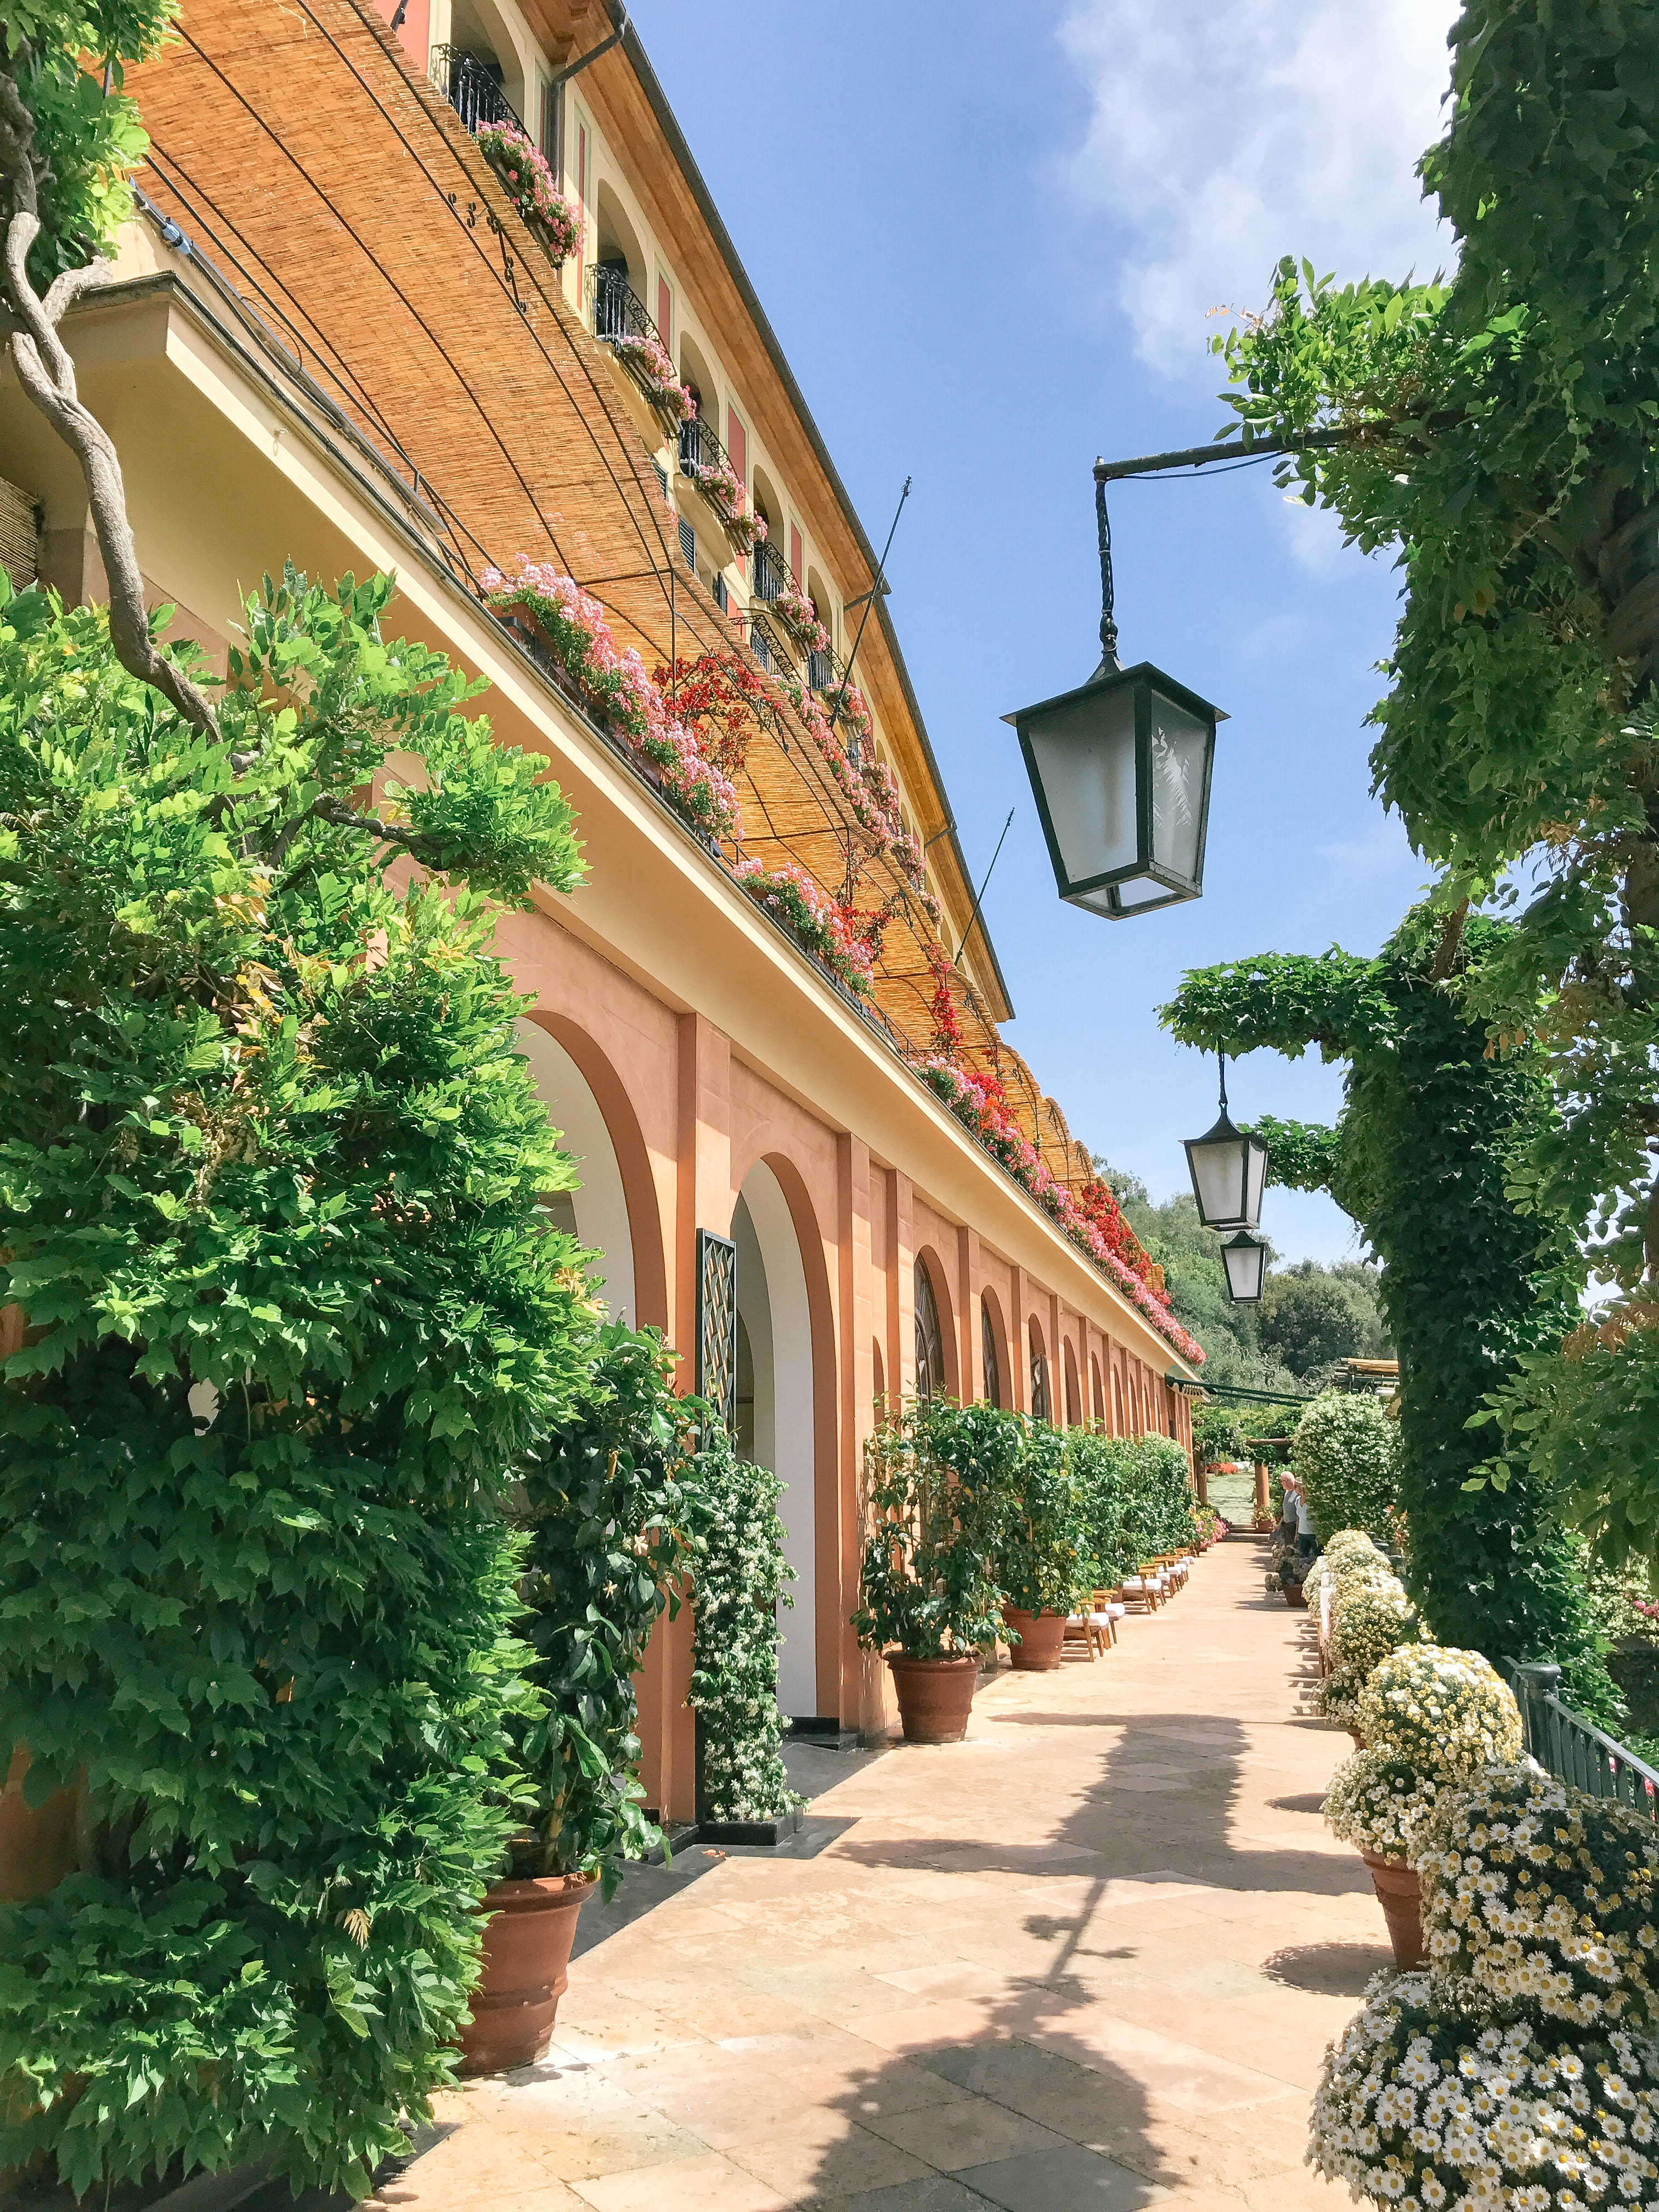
[851,1400,1022,1743]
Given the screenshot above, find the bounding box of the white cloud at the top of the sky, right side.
[1059,0,1455,374]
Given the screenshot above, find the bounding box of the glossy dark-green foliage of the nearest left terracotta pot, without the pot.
[513,1323,692,1895]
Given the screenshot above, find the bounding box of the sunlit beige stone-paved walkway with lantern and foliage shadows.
[383,1537,1387,2212]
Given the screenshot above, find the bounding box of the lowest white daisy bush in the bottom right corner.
[1310,1973,1659,2212]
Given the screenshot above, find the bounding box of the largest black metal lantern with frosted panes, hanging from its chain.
[1002,462,1226,920]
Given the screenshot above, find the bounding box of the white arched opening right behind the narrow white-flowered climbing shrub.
[732,1161,819,1719]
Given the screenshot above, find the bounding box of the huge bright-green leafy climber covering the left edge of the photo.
[0,571,589,2194]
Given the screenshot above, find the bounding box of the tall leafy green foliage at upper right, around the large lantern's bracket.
[1186,0,1659,1558]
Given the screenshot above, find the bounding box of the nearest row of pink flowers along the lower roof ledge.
[480,553,743,843]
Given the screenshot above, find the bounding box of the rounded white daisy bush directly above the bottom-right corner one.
[1413,1768,1659,2028]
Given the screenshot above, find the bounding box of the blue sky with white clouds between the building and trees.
[633,0,1453,1259]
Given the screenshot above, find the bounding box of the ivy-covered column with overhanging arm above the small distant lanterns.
[1164,909,1615,1717]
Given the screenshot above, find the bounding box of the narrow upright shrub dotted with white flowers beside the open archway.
[686,1420,801,1820]
